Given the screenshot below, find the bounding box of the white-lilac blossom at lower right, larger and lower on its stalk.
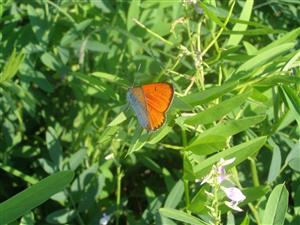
[221,187,246,212]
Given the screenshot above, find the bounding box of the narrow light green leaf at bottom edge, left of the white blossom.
[159,208,208,225]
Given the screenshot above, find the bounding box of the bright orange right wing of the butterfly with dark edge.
[142,83,174,130]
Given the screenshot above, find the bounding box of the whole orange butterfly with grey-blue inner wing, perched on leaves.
[127,83,174,131]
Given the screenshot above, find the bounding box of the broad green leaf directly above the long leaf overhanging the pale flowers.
[185,115,265,155]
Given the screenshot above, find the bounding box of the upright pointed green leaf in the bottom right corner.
[262,184,289,225]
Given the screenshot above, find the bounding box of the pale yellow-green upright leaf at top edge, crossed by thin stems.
[226,0,254,46]
